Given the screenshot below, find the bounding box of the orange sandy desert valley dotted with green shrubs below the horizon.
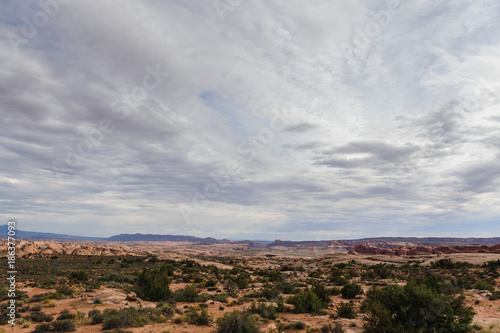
[0,235,500,333]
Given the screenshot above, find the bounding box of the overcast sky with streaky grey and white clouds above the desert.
[0,0,500,240]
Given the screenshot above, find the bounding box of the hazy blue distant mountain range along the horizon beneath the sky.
[0,225,500,248]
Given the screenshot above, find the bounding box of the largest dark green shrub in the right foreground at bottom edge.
[362,281,474,333]
